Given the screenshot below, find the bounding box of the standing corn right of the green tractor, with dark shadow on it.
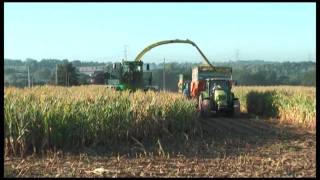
[234,86,316,130]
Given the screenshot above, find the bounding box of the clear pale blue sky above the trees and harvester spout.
[4,3,316,62]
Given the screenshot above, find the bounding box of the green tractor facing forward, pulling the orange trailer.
[198,78,240,117]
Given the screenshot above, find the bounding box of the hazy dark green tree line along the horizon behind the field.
[4,59,316,91]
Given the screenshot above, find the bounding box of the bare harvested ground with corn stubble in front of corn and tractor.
[4,115,316,177]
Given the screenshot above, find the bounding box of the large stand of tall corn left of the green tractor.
[4,86,196,154]
